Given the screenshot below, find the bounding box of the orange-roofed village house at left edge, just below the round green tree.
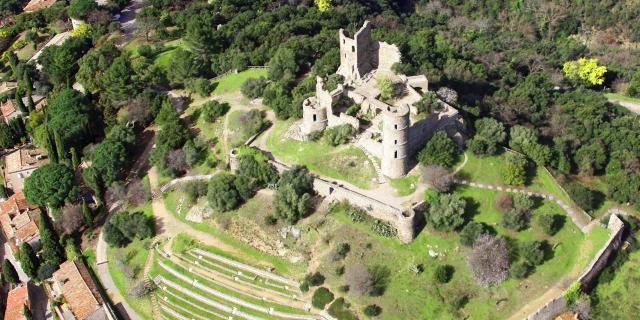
[0,192,40,255]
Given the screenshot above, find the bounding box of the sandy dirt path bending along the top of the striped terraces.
[149,167,237,252]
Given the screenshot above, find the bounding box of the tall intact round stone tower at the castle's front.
[382,105,410,178]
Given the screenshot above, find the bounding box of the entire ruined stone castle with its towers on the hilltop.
[300,21,464,178]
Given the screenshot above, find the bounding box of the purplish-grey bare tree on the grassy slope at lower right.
[467,235,509,287]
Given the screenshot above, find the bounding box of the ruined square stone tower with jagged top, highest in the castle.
[337,21,377,80]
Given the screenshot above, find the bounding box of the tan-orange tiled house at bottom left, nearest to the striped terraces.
[45,259,116,320]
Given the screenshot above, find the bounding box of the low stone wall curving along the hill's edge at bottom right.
[527,211,624,320]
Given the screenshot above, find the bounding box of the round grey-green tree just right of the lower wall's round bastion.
[427,194,467,231]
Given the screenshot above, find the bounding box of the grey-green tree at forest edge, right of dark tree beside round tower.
[468,118,507,155]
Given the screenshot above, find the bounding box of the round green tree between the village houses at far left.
[24,163,78,208]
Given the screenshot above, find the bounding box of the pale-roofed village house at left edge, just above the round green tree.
[3,147,49,193]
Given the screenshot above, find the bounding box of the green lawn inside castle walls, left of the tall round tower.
[266,121,376,189]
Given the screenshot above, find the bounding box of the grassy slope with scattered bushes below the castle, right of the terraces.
[320,187,608,319]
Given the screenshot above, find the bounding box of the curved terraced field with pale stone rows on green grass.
[149,244,322,320]
